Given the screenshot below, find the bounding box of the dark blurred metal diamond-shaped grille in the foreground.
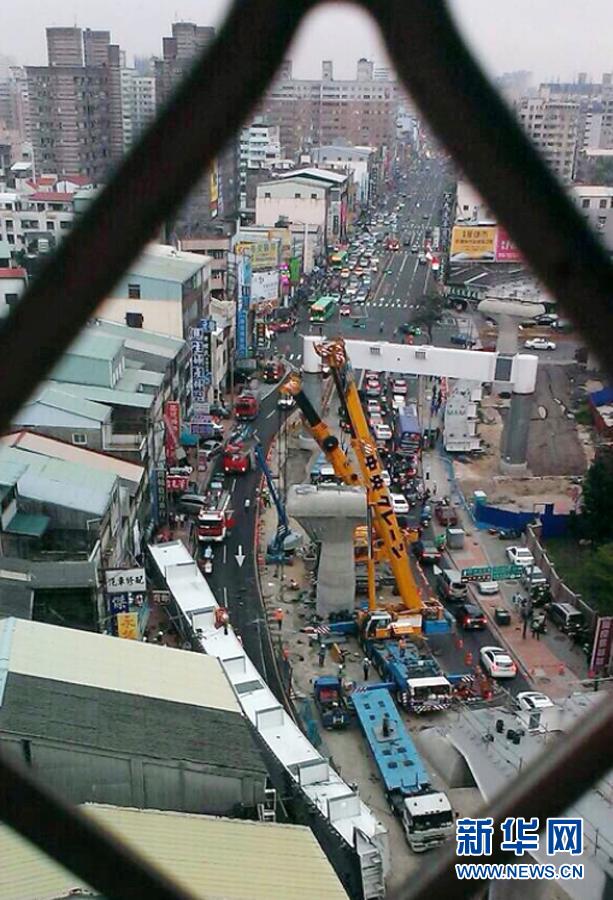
[0,0,613,900]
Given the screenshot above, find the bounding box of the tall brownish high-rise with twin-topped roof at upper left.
[26,28,123,181]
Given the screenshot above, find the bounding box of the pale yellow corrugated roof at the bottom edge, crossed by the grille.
[0,805,347,900]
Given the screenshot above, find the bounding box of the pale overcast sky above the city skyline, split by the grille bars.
[0,0,613,81]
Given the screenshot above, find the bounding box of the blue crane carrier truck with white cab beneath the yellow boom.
[364,640,452,715]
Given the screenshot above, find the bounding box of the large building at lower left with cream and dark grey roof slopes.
[0,619,267,819]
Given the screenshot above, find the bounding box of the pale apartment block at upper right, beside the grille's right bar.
[516,97,580,181]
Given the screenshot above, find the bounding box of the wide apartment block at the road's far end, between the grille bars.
[260,59,399,159]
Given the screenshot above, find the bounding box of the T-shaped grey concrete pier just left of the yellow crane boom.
[287,484,366,619]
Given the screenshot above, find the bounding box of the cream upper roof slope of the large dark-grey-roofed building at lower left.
[0,619,240,716]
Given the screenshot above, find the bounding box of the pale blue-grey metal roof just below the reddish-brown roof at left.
[0,446,117,516]
